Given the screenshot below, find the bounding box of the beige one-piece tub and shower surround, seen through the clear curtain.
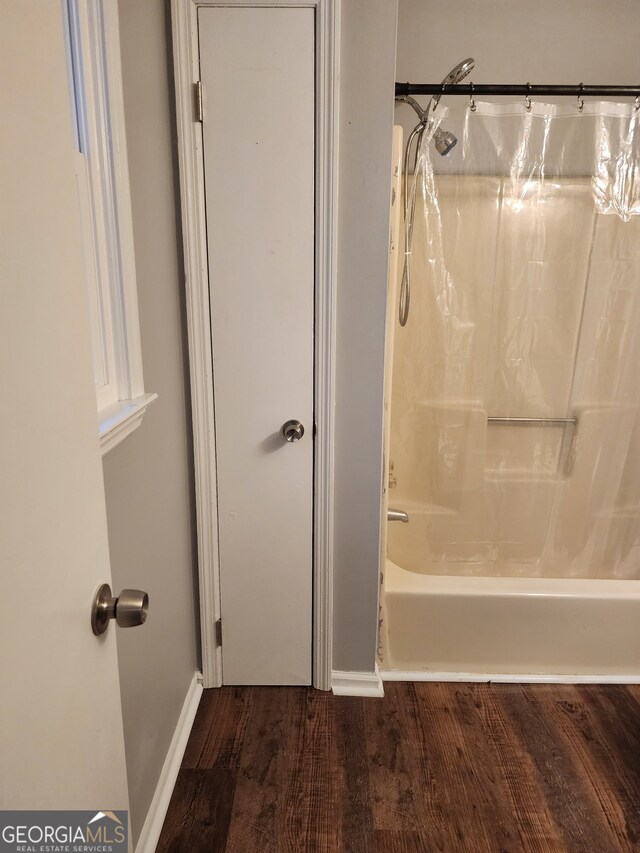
[381,95,640,682]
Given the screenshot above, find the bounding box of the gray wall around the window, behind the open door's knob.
[104,0,197,840]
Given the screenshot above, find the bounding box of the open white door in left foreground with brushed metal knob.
[0,0,128,820]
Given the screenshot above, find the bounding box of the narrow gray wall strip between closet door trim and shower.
[333,0,397,672]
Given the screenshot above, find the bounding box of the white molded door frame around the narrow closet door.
[171,0,341,690]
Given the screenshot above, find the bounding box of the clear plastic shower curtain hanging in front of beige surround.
[389,102,640,578]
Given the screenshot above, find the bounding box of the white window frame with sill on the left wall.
[63,0,157,455]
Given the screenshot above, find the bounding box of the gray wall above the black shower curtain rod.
[396,0,640,138]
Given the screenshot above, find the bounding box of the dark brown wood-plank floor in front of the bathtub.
[157,682,640,853]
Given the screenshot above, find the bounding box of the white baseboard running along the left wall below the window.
[136,672,202,853]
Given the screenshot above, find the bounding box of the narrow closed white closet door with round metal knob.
[198,7,315,684]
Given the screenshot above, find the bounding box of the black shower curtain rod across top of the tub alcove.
[396,83,640,98]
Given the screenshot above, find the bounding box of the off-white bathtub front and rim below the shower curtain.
[380,560,640,683]
